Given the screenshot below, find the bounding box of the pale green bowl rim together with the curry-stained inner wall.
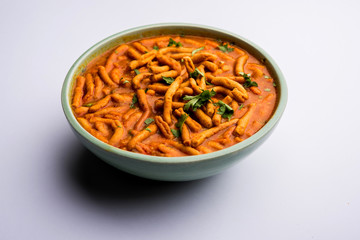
[61,23,287,164]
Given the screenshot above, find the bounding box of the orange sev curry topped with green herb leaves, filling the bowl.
[72,35,276,157]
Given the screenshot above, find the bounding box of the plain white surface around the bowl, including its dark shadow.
[0,0,360,240]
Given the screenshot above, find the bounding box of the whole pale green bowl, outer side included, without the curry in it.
[61,23,287,181]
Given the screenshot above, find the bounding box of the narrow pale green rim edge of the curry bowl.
[61,23,288,164]
